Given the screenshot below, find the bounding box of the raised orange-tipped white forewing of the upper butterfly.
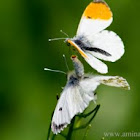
[77,0,113,36]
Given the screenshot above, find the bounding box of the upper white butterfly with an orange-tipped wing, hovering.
[50,0,124,73]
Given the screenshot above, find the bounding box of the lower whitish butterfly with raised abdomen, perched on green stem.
[49,55,130,134]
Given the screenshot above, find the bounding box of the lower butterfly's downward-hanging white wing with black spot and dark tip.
[51,85,93,134]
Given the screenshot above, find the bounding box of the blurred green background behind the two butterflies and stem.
[0,0,140,140]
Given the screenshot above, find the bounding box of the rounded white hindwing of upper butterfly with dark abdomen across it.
[85,30,124,62]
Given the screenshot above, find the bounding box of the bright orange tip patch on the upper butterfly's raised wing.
[83,0,112,20]
